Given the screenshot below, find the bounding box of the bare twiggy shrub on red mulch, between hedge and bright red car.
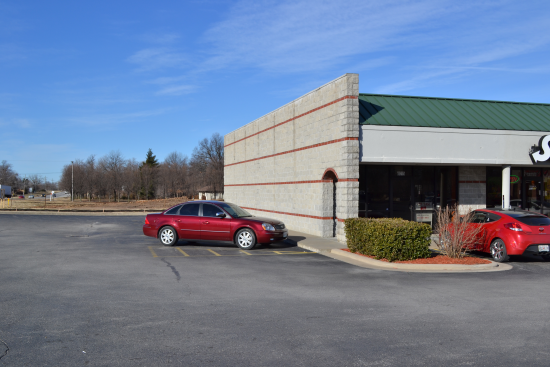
[435,204,484,259]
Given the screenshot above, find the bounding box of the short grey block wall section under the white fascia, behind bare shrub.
[458,166,487,214]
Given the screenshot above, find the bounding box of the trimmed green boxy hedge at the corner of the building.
[344,218,432,261]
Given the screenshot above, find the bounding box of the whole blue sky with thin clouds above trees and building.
[0,0,550,179]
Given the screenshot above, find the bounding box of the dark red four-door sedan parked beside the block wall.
[143,201,288,250]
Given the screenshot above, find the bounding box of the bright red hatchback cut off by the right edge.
[473,209,550,262]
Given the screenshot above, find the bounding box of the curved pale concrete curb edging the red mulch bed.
[330,249,513,273]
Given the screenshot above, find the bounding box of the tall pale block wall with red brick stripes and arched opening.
[224,74,359,241]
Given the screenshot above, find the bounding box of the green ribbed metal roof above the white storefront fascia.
[359,94,550,131]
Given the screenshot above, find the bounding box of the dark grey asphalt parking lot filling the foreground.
[0,214,550,366]
